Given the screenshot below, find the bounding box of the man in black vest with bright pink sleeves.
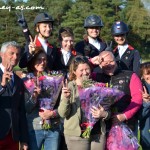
[96,51,142,134]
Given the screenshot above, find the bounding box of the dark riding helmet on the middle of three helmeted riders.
[84,15,104,28]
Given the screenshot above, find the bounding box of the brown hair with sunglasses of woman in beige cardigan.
[69,55,92,81]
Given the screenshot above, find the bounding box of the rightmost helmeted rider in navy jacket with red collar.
[111,21,141,75]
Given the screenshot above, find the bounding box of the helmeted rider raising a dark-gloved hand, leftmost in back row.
[18,13,57,70]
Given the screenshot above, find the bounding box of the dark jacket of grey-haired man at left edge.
[0,69,28,144]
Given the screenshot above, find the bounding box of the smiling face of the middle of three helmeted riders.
[87,27,100,39]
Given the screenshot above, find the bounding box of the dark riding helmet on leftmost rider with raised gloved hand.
[34,13,54,26]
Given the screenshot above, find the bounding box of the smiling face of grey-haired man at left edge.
[1,46,20,67]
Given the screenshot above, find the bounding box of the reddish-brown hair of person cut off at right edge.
[140,62,150,78]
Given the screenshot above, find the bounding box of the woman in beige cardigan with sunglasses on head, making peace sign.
[58,56,110,150]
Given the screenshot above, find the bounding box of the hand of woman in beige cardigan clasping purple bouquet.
[91,105,107,119]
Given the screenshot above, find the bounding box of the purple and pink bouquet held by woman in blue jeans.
[24,72,64,130]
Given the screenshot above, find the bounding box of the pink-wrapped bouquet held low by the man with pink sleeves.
[106,123,139,150]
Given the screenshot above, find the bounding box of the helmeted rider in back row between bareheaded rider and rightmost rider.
[75,15,107,58]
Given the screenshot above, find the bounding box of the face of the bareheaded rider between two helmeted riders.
[61,36,74,51]
